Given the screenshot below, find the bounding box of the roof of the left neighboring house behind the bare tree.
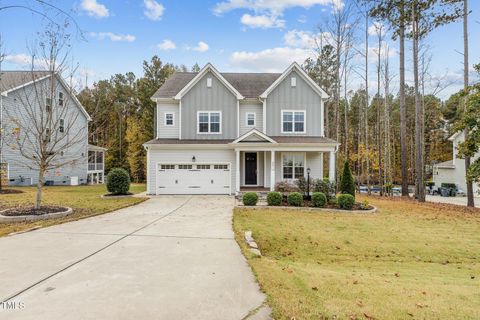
[0,71,92,121]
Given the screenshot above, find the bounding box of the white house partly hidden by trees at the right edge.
[433,132,480,195]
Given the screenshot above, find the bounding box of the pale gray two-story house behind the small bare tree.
[0,71,106,186]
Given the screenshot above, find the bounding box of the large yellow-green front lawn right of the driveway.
[234,197,480,320]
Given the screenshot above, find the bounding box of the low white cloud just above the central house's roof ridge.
[230,47,313,72]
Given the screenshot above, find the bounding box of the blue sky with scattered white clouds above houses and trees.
[0,0,480,98]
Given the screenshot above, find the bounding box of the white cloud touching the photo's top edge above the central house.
[213,0,344,15]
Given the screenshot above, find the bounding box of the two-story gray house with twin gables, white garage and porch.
[144,63,339,194]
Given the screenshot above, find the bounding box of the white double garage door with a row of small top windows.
[157,163,231,194]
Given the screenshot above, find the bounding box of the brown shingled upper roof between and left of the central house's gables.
[152,72,281,99]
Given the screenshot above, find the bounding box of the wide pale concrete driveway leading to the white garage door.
[0,196,265,319]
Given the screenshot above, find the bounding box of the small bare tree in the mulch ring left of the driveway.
[6,26,88,209]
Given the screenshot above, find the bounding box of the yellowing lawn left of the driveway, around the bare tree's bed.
[0,184,145,236]
